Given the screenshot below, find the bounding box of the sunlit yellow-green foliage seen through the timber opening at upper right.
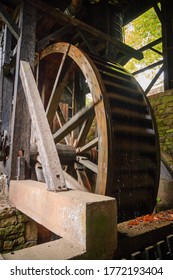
[124,8,162,73]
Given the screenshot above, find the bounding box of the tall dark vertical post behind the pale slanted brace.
[9,2,36,179]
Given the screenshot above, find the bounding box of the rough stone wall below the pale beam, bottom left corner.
[0,197,38,253]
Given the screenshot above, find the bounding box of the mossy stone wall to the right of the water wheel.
[149,89,173,170]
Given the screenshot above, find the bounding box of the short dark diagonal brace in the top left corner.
[0,3,20,40]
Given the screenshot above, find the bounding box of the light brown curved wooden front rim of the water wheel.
[39,42,112,195]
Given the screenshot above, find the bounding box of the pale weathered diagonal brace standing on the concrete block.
[20,61,67,191]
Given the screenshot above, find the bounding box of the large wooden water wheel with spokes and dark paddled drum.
[36,43,160,221]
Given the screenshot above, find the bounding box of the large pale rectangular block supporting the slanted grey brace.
[9,180,117,258]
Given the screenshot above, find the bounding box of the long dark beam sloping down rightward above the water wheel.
[27,0,143,59]
